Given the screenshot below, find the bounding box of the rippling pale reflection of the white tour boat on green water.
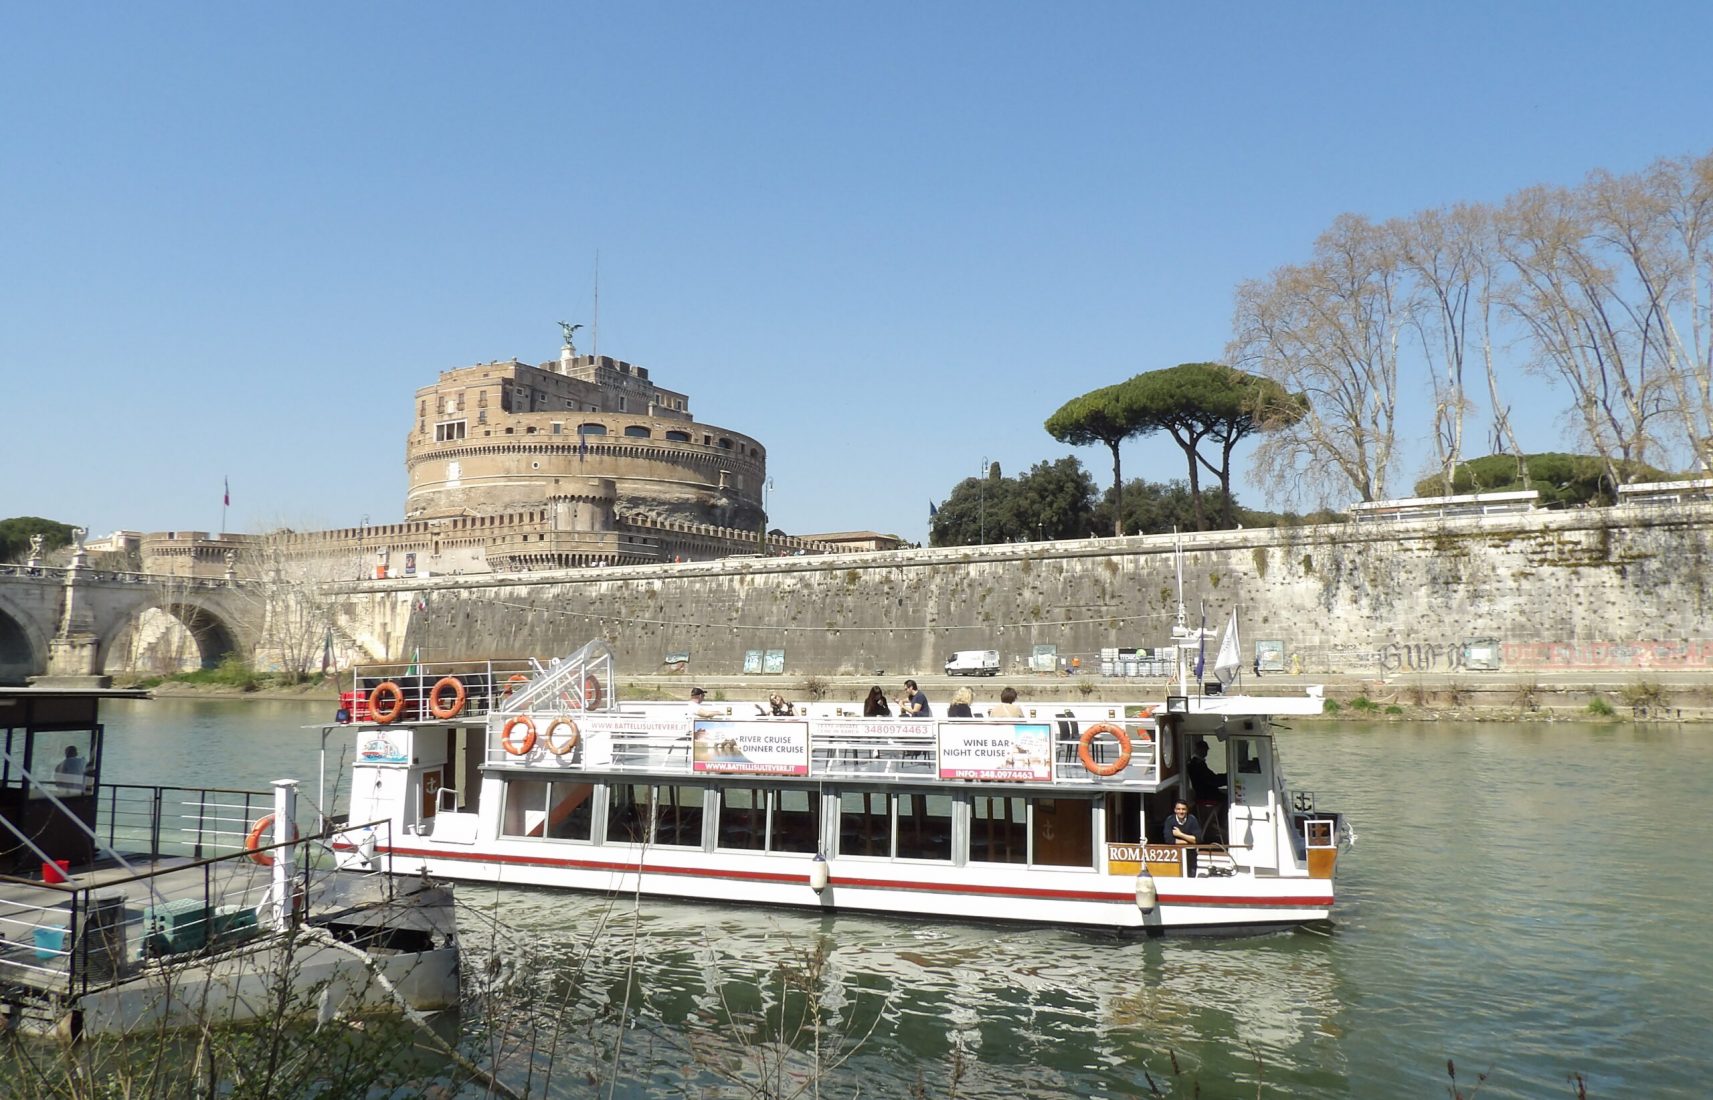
[461,886,1341,1097]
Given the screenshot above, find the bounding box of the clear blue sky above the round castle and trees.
[0,2,1713,540]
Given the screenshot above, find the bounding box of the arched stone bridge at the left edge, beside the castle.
[0,548,259,684]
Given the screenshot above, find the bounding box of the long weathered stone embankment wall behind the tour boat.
[323,504,1713,677]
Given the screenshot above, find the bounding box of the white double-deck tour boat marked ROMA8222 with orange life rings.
[337,641,1345,932]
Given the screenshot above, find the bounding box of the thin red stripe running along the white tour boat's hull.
[375,845,1333,908]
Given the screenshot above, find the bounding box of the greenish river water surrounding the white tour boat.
[86,699,1713,1100]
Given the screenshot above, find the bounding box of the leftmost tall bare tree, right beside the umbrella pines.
[1230,214,1410,504]
